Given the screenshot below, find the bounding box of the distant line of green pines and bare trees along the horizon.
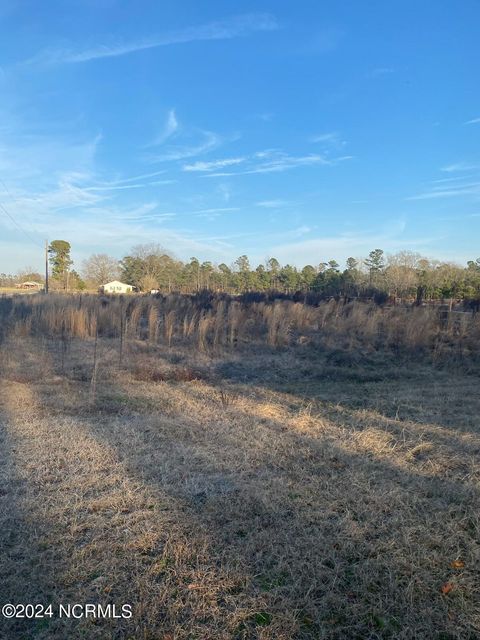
[0,240,480,301]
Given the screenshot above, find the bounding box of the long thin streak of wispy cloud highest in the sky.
[26,13,278,65]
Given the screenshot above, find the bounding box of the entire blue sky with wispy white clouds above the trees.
[0,0,480,272]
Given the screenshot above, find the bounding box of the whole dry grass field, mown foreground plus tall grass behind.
[0,297,480,640]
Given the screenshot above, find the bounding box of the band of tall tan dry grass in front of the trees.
[0,294,480,362]
